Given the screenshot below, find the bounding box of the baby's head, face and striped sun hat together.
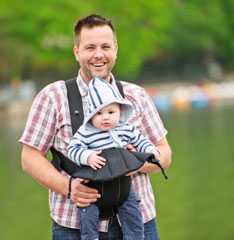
[83,77,132,130]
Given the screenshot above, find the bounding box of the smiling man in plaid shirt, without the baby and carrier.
[20,15,171,240]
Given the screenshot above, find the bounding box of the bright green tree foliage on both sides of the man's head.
[0,0,174,80]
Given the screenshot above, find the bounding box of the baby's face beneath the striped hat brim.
[91,103,120,131]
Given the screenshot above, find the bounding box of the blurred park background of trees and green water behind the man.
[0,0,234,240]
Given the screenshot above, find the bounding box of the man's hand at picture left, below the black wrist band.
[71,178,101,207]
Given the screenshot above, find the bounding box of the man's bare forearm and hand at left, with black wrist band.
[21,144,100,207]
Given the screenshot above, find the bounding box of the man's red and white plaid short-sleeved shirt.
[19,75,167,231]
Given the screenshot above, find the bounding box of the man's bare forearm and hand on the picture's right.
[138,138,172,173]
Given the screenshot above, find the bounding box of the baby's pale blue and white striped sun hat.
[84,77,133,125]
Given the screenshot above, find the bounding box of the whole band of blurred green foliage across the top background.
[0,0,234,81]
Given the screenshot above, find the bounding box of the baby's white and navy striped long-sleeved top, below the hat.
[68,123,155,166]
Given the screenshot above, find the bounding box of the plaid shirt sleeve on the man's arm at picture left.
[19,88,56,153]
